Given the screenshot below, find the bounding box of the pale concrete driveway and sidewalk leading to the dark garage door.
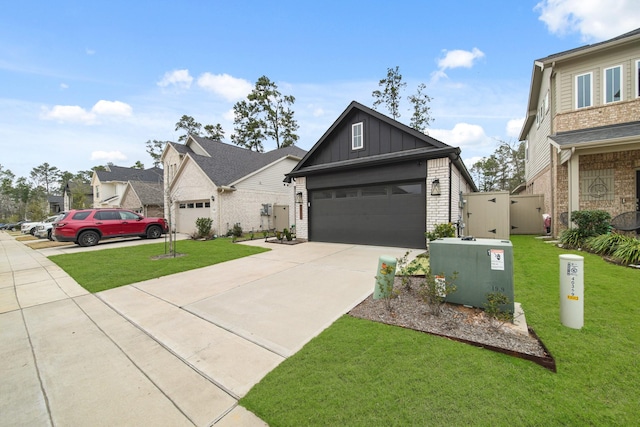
[0,232,418,426]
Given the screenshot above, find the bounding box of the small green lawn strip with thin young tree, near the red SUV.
[49,239,269,292]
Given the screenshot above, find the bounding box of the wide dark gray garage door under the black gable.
[309,181,427,248]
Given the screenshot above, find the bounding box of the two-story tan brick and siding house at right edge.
[520,29,640,235]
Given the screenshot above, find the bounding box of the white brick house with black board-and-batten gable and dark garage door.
[287,101,477,248]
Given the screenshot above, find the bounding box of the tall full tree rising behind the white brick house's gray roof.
[231,76,299,152]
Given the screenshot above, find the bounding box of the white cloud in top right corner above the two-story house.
[534,0,640,41]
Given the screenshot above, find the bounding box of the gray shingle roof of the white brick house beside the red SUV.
[171,136,307,186]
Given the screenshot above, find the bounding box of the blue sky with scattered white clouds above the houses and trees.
[0,0,640,181]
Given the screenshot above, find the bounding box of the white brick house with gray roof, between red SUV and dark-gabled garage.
[162,136,306,234]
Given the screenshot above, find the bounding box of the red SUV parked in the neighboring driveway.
[53,209,168,246]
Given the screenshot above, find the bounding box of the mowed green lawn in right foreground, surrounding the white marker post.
[240,236,640,426]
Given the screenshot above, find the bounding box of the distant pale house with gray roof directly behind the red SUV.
[91,165,163,208]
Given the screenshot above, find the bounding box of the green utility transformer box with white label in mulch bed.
[429,237,514,313]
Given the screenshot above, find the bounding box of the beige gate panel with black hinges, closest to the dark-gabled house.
[463,191,510,240]
